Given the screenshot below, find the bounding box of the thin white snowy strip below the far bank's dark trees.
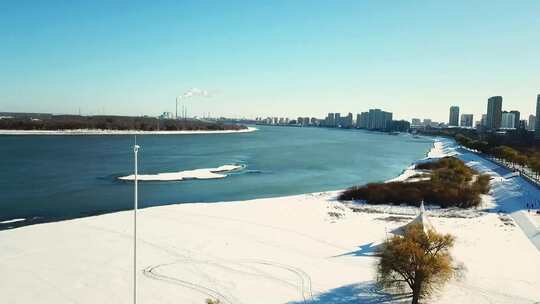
[0,127,258,135]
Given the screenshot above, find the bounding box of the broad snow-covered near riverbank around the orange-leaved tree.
[0,141,540,304]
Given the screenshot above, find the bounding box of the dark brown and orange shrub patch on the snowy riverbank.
[339,157,490,208]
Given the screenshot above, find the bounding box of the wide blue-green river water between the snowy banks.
[0,126,432,230]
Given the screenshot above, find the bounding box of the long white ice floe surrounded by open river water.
[118,165,245,181]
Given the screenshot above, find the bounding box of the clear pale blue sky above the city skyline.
[0,0,540,121]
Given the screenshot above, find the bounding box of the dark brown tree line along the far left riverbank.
[0,115,246,131]
